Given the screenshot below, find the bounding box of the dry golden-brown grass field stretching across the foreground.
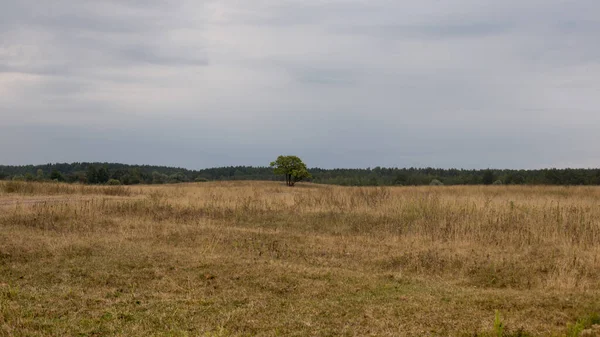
[0,182,600,337]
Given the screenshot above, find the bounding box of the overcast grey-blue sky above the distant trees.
[0,0,600,169]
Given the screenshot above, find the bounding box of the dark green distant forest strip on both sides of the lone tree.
[0,163,600,186]
